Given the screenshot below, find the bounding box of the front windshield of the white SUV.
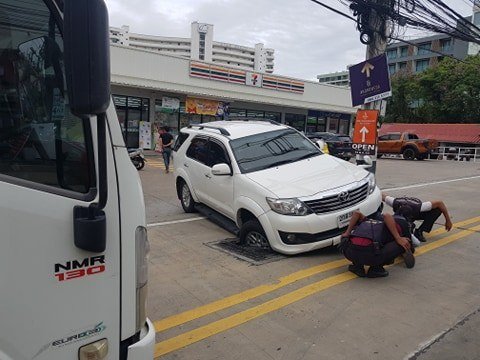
[230,129,322,173]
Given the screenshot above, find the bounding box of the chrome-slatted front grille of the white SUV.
[304,183,368,214]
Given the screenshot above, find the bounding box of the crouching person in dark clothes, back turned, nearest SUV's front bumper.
[339,211,415,278]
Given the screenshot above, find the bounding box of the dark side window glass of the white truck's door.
[0,0,95,197]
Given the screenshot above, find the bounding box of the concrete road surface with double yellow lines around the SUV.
[140,157,480,360]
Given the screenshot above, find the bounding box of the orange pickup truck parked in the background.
[378,132,438,160]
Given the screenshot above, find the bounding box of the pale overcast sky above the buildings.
[105,0,472,80]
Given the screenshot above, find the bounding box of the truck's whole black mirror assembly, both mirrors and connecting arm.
[63,0,110,253]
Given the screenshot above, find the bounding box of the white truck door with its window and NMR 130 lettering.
[0,0,121,360]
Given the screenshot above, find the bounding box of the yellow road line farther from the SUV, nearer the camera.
[154,225,480,357]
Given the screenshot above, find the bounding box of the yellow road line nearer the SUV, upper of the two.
[154,216,480,332]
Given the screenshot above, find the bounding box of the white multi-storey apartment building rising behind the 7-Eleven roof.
[110,21,274,74]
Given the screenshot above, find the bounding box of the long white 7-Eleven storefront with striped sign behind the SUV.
[112,46,356,149]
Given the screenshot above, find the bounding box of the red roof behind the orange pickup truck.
[379,123,480,144]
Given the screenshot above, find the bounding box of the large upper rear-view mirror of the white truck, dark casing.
[63,0,110,115]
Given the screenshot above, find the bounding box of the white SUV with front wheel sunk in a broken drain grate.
[174,121,381,254]
